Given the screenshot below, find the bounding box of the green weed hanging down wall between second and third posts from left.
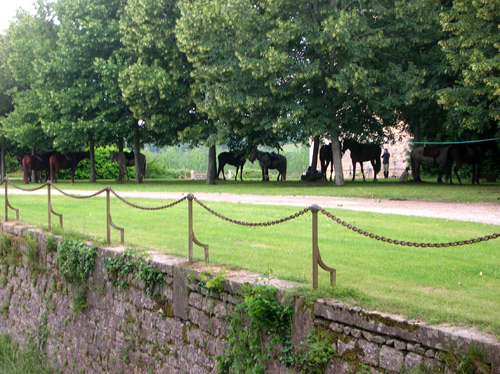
[56,238,97,313]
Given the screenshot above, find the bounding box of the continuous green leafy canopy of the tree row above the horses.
[0,0,500,184]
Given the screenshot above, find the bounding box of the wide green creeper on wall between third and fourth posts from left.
[104,248,165,297]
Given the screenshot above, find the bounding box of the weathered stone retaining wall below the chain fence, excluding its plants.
[0,223,500,374]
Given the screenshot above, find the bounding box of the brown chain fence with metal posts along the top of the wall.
[0,178,500,289]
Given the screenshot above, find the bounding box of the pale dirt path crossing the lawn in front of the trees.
[9,190,500,226]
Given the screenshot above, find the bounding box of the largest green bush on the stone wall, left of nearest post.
[217,284,293,374]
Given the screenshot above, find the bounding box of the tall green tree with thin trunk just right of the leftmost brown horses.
[38,0,125,181]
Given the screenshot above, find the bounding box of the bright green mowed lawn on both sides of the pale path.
[1,181,500,335]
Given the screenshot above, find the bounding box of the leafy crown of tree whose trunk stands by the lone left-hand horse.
[119,0,196,183]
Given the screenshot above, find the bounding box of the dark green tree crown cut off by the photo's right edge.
[440,0,500,139]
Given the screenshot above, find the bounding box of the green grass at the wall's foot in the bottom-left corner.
[0,334,54,374]
